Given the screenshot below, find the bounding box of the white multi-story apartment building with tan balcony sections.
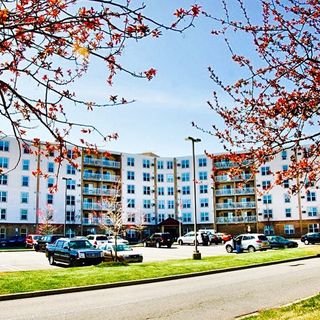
[0,138,320,238]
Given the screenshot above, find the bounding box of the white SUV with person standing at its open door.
[225,233,271,253]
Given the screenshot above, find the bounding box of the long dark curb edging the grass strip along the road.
[0,254,320,301]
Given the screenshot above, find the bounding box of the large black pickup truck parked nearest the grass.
[46,238,103,266]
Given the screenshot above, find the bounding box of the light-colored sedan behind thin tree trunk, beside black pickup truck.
[99,243,143,262]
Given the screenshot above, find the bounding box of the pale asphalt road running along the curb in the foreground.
[0,258,320,320]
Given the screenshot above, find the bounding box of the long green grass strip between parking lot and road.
[0,246,320,294]
